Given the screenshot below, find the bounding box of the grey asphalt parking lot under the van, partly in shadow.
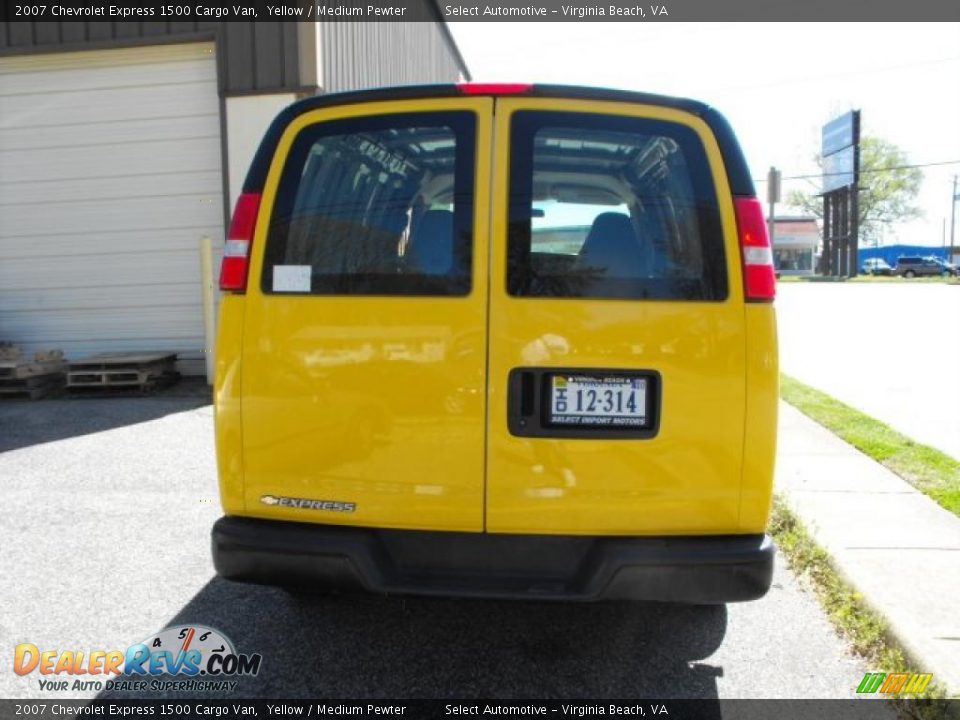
[0,395,879,700]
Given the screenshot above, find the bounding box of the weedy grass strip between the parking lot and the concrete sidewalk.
[770,497,948,708]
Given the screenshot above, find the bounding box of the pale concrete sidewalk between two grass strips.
[776,402,960,694]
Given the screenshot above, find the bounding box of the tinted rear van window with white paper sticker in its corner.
[261,112,475,295]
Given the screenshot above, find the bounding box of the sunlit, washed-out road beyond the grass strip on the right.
[777,280,960,458]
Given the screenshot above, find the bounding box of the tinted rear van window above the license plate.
[507,112,727,300]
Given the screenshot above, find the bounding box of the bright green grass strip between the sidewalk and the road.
[780,375,960,516]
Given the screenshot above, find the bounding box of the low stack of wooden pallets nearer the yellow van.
[67,353,179,391]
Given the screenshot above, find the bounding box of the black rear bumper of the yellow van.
[212,517,774,604]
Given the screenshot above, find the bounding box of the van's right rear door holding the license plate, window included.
[486,97,745,534]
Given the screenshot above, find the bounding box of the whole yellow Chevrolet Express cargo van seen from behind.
[212,83,777,604]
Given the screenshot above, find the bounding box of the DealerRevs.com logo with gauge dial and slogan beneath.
[13,625,263,691]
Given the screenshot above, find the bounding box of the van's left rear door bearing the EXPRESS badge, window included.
[241,97,493,531]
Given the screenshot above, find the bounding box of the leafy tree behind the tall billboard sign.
[787,137,923,243]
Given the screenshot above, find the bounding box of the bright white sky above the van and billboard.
[450,22,960,245]
